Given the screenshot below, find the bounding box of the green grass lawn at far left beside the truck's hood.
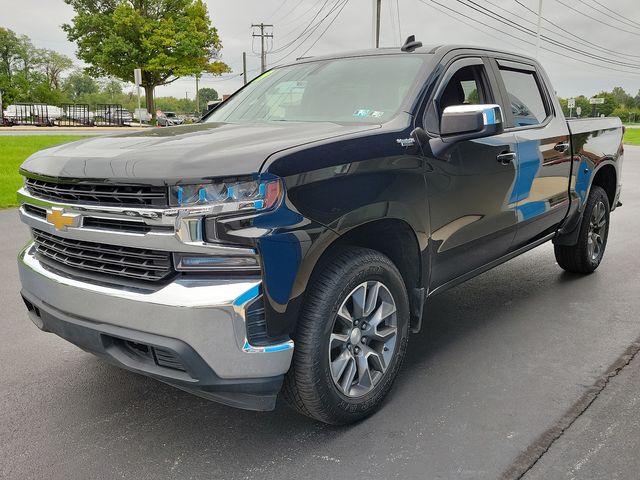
[0,135,86,208]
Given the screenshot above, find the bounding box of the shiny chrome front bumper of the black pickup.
[18,243,294,378]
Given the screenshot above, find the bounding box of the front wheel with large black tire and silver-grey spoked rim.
[283,247,409,425]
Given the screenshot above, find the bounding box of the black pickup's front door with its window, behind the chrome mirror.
[425,57,517,290]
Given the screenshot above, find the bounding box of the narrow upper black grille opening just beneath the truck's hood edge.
[25,178,167,207]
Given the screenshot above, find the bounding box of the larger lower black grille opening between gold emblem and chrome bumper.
[33,229,173,281]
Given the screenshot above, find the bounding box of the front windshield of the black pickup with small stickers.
[205,55,424,123]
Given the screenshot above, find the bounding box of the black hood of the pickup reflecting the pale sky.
[22,122,380,184]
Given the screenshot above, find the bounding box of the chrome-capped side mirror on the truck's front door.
[440,105,504,143]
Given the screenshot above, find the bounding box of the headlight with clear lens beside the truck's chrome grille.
[170,175,282,211]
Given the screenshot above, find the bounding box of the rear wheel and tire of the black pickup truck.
[554,186,610,273]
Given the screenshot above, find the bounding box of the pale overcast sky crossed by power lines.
[0,0,640,98]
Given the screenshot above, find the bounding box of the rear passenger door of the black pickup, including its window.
[492,58,571,249]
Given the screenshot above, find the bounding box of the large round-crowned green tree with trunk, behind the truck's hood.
[62,0,230,116]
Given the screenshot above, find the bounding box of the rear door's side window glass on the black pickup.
[500,68,549,127]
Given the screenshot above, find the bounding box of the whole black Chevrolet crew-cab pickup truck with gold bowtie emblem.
[18,41,623,424]
